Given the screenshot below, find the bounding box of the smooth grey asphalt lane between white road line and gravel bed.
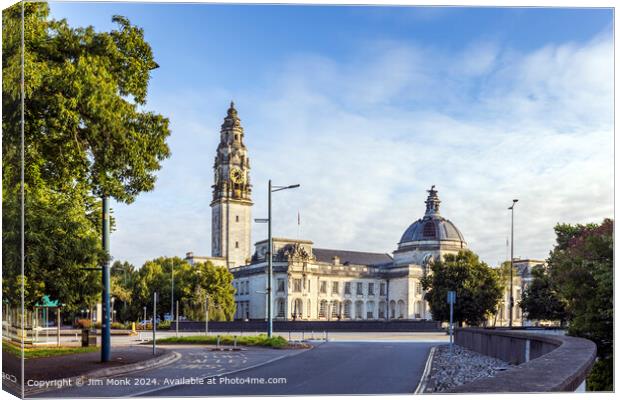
[148,342,433,397]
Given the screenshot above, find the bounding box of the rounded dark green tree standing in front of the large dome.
[422,250,502,326]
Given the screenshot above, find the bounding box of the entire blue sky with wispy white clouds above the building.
[46,2,614,266]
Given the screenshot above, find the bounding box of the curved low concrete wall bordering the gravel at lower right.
[452,328,596,393]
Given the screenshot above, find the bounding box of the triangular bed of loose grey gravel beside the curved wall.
[424,345,514,393]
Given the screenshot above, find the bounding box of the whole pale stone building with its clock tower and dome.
[186,103,478,320]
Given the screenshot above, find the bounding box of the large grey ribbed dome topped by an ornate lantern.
[399,185,465,246]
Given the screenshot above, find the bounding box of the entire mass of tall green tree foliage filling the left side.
[3,3,169,310]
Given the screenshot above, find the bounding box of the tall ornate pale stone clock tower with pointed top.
[211,102,252,268]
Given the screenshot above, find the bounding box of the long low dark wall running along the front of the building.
[170,320,443,332]
